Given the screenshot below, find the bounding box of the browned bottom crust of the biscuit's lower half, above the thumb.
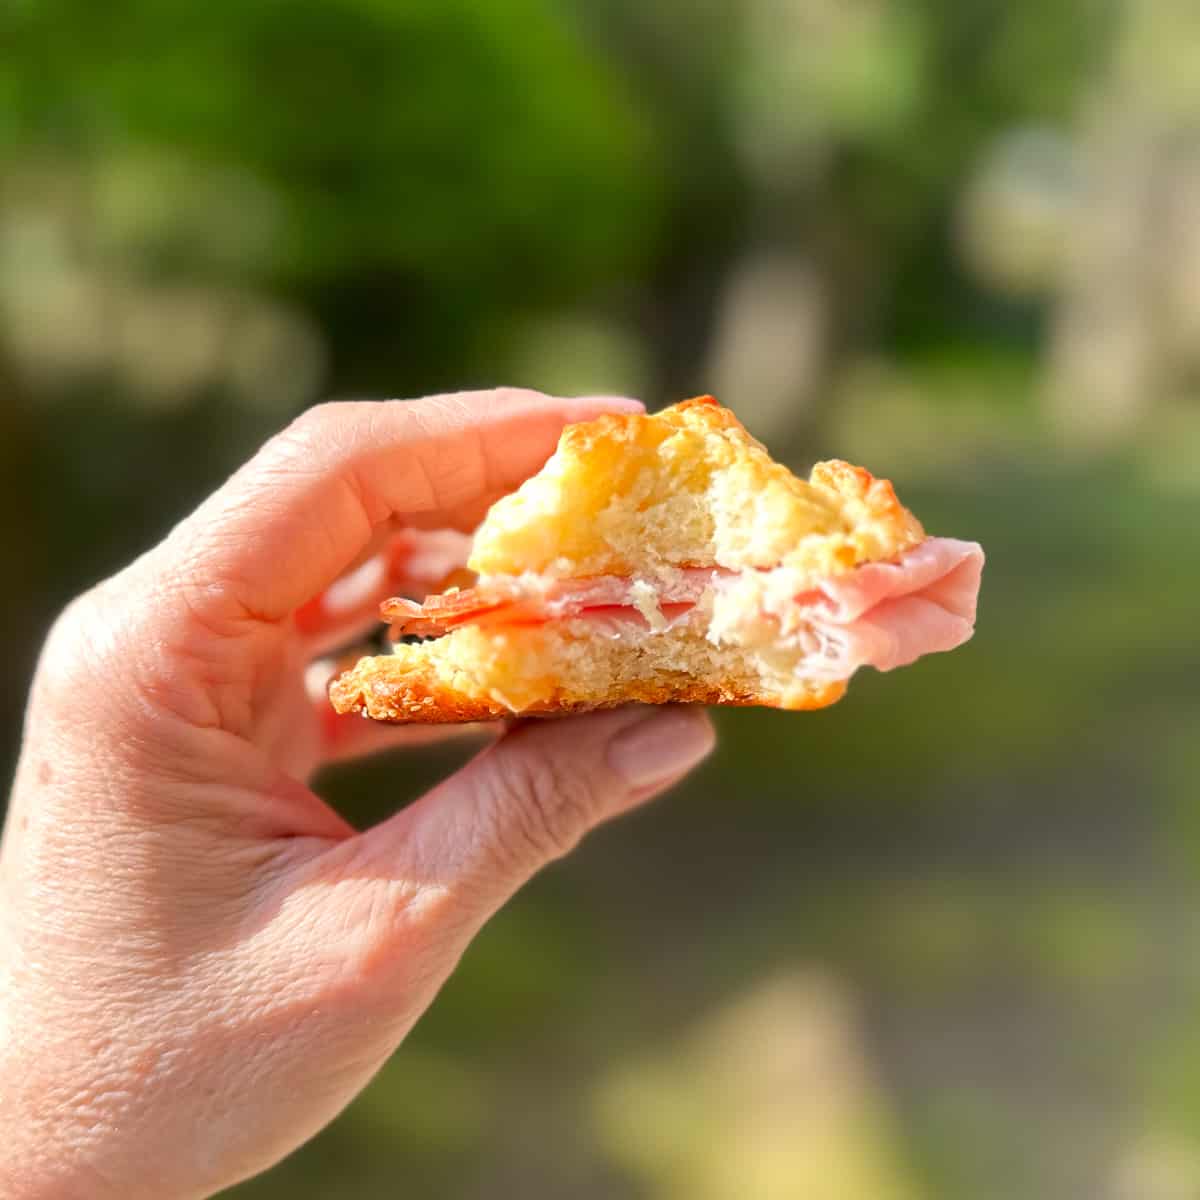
[329,655,846,725]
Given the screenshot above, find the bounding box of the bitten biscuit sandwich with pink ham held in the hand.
[330,396,983,722]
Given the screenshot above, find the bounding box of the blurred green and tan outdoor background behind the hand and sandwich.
[0,0,1200,1200]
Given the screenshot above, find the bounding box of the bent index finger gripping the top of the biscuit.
[156,389,642,622]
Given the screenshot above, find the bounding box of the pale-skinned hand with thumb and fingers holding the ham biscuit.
[0,390,713,1200]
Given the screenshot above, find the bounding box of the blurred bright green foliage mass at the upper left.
[0,0,656,296]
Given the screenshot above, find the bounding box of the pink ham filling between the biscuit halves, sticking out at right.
[382,538,984,679]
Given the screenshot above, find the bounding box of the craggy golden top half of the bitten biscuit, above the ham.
[469,396,924,578]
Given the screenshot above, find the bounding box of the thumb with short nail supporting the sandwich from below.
[366,707,714,923]
